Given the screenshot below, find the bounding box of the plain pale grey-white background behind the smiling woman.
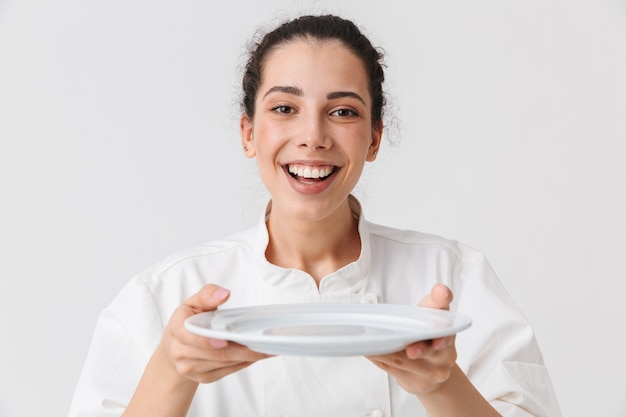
[0,0,626,417]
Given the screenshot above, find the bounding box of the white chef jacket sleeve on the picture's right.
[455,250,561,417]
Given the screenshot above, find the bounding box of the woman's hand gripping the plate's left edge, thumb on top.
[159,284,268,383]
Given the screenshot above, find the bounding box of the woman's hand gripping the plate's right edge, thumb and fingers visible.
[368,284,457,395]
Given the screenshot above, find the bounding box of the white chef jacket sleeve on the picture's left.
[69,278,163,417]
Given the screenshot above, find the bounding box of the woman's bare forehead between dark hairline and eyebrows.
[261,38,369,96]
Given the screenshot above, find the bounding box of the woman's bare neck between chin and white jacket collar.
[265,201,361,286]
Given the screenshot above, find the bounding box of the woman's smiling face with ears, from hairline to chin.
[241,40,382,221]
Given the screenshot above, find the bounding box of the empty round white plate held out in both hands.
[185,303,471,356]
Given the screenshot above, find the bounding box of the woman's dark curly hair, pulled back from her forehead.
[242,15,385,125]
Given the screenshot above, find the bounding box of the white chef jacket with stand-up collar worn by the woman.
[69,197,561,417]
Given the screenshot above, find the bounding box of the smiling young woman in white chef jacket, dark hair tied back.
[70,16,560,417]
